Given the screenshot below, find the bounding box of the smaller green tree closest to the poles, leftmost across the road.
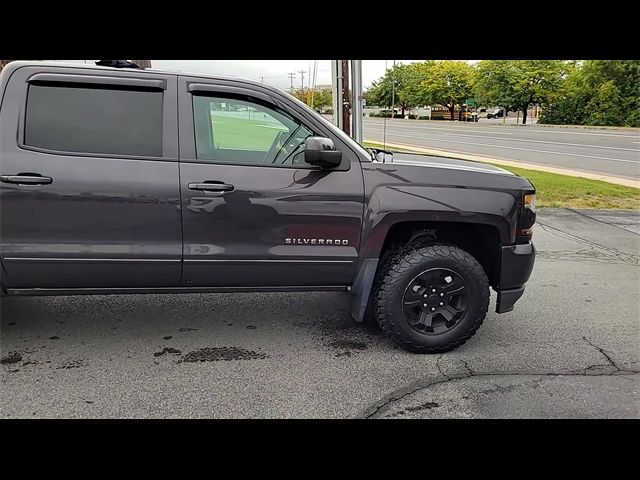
[365,64,419,117]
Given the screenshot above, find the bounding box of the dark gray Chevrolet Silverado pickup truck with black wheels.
[0,62,535,353]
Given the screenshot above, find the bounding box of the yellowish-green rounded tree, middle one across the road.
[416,60,474,120]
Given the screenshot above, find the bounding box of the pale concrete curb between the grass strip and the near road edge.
[365,140,640,188]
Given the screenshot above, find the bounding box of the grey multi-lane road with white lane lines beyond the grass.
[363,117,640,180]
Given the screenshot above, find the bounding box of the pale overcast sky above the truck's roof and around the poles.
[55,60,418,89]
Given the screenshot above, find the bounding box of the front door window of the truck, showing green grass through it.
[193,95,313,166]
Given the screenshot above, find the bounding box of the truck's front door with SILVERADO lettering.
[178,77,363,288]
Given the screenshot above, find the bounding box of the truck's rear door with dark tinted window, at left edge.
[0,67,182,288]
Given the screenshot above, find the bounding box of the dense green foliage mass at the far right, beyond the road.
[540,60,640,127]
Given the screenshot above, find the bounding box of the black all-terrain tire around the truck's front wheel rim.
[374,243,489,353]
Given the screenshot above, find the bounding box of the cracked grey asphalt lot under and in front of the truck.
[0,209,640,418]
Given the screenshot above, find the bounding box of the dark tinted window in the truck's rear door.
[25,85,162,157]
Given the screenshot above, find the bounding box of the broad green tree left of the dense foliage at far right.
[474,60,572,124]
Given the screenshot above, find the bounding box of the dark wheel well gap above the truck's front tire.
[380,222,500,286]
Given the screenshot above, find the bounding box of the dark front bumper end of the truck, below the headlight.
[495,242,536,313]
